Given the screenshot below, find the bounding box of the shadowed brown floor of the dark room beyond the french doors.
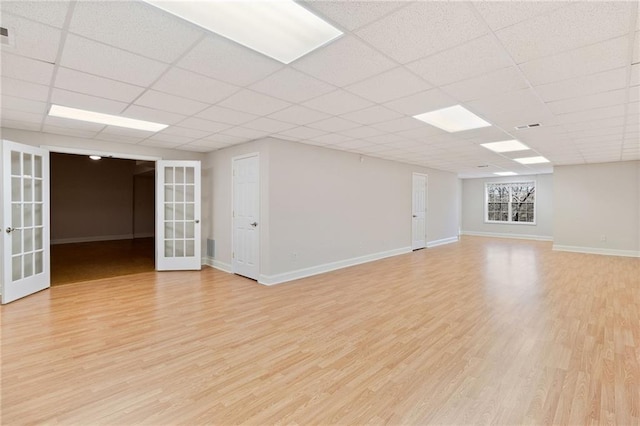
[51,238,155,285]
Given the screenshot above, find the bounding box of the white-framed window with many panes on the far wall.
[485,181,536,224]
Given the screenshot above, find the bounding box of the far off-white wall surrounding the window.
[462,174,554,240]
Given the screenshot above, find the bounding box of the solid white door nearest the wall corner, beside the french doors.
[232,154,260,280]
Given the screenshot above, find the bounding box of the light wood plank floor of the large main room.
[1,237,640,425]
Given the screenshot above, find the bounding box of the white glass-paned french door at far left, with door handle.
[0,140,51,304]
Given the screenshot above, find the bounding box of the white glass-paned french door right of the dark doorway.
[156,161,202,271]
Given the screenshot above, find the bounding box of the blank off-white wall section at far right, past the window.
[553,161,640,256]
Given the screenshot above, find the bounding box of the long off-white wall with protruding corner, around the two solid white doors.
[207,139,458,283]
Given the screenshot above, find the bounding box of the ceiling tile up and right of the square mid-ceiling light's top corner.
[442,67,528,102]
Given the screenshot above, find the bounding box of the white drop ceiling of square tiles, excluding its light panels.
[1,0,640,177]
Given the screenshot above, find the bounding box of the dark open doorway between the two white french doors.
[50,152,155,285]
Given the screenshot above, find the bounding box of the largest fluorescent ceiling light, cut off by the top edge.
[145,0,342,64]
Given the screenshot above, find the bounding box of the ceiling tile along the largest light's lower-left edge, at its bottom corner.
[177,34,282,86]
